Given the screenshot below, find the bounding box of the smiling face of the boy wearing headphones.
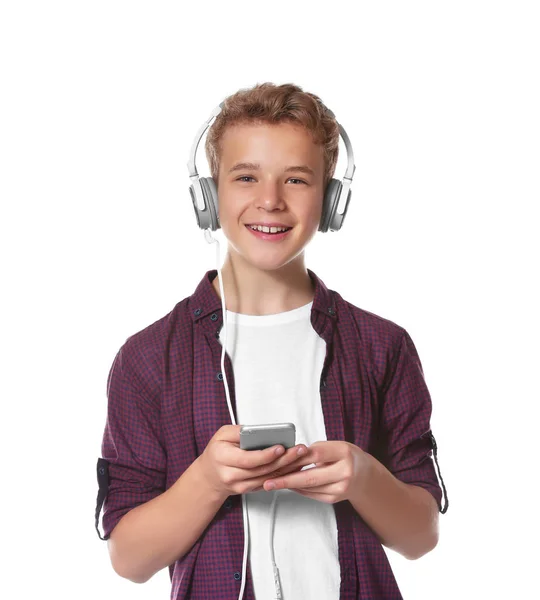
[216,123,324,270]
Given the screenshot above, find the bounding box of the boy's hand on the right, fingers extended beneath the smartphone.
[263,440,369,504]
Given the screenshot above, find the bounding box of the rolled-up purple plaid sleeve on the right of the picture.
[379,328,442,511]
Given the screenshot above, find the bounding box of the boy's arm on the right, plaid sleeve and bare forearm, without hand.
[351,328,446,560]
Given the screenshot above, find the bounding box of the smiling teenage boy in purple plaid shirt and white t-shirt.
[96,83,448,600]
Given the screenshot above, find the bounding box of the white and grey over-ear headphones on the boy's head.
[187,102,356,233]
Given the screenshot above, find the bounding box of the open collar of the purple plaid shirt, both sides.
[189,269,337,322]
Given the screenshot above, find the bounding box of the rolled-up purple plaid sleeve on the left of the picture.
[101,343,166,539]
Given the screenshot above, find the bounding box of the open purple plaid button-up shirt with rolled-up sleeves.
[96,269,448,600]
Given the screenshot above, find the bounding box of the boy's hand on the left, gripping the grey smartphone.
[197,425,313,498]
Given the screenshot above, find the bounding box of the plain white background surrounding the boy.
[0,0,540,600]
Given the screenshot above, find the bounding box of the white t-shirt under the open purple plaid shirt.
[220,302,340,600]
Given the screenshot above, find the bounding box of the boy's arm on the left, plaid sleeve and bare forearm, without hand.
[98,345,225,583]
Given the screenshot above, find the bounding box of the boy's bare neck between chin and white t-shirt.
[212,252,315,315]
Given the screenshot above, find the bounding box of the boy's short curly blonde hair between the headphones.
[205,82,339,188]
